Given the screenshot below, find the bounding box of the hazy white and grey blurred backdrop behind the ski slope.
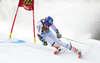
[0,0,100,40]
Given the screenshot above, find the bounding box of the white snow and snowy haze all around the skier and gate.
[0,0,100,63]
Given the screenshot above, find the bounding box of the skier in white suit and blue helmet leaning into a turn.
[37,16,81,58]
